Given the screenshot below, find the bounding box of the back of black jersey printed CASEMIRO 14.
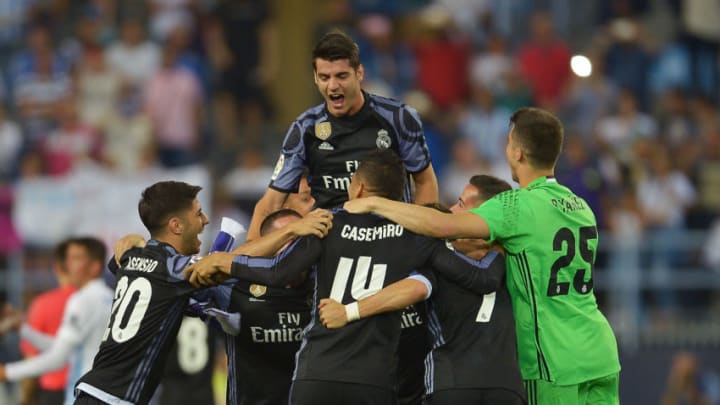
[295,211,441,389]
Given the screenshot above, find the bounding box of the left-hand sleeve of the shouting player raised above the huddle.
[270,121,305,193]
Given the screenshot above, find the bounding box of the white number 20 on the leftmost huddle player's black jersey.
[103,276,152,343]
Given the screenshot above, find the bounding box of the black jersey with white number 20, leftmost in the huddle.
[78,240,198,404]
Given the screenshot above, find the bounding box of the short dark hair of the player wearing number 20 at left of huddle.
[138,181,202,236]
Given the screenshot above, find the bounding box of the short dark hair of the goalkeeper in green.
[510,107,563,169]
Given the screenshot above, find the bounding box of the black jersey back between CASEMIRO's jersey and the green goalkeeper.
[425,251,525,396]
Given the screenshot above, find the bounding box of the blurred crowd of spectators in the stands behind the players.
[0,0,720,340]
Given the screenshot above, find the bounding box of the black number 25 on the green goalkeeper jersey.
[547,226,597,297]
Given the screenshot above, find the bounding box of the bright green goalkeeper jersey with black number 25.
[472,177,620,385]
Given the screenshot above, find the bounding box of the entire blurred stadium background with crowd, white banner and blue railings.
[0,0,720,405]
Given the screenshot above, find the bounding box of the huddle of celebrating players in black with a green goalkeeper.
[1,32,620,405]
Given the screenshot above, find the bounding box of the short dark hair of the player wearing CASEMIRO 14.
[355,149,407,201]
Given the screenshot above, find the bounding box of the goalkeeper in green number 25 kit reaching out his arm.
[345,108,620,405]
